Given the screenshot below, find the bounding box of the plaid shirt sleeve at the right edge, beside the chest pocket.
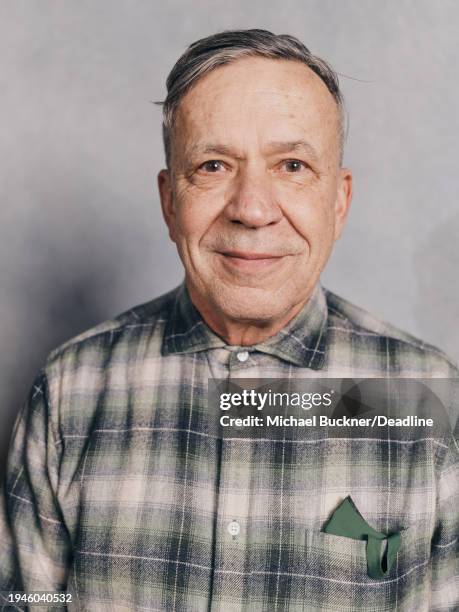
[430,426,459,611]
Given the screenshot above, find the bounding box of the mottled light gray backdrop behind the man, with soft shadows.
[0,0,459,466]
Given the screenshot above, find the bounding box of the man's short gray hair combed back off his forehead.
[155,29,346,168]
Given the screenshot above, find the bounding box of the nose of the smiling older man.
[225,167,282,229]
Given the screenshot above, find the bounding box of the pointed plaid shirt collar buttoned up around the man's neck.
[161,283,328,370]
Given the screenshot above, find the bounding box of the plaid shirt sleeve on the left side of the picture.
[0,371,71,603]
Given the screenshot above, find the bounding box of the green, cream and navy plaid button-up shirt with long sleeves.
[0,284,459,612]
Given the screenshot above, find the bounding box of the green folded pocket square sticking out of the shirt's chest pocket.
[322,496,401,579]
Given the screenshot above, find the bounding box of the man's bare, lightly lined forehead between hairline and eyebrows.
[174,57,339,158]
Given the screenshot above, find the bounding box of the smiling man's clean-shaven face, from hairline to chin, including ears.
[158,57,351,324]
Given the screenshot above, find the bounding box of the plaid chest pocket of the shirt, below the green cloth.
[305,525,430,612]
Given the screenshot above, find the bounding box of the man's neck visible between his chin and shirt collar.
[188,287,307,346]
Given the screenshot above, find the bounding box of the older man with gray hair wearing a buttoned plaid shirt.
[0,30,458,612]
